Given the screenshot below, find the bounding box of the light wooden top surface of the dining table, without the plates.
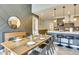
[1,35,51,55]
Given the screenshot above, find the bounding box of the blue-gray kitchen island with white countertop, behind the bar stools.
[47,31,79,48]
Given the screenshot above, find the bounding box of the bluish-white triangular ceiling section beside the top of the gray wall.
[32,4,58,13]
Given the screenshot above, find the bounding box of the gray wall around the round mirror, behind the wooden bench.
[0,4,32,42]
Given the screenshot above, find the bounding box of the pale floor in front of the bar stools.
[55,46,79,55]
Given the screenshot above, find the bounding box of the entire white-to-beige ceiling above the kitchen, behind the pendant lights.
[32,4,79,20]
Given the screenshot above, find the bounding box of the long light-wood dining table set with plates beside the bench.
[1,35,51,55]
